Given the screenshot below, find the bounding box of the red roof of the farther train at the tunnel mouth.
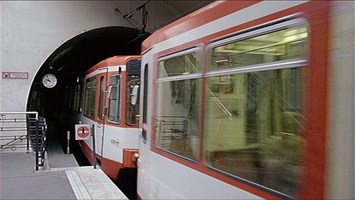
[86,55,141,74]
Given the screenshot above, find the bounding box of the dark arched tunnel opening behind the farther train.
[27,26,149,165]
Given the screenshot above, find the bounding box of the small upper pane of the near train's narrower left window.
[158,53,201,78]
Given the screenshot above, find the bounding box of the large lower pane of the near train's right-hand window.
[204,67,304,196]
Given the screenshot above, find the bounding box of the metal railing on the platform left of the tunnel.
[0,112,47,170]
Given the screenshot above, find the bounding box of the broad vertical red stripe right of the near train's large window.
[299,1,330,199]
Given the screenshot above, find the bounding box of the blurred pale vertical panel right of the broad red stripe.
[326,1,355,199]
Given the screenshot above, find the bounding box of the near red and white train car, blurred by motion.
[136,1,355,199]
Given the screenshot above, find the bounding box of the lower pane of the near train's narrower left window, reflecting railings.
[154,79,201,160]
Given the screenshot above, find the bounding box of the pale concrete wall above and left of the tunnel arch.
[0,1,184,112]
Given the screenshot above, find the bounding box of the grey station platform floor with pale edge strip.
[0,143,128,199]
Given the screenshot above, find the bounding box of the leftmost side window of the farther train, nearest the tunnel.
[84,78,97,118]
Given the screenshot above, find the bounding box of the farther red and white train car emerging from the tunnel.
[79,56,141,180]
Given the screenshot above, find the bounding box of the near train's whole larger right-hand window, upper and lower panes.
[204,22,308,196]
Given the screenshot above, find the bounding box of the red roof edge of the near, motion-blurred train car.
[142,1,260,52]
